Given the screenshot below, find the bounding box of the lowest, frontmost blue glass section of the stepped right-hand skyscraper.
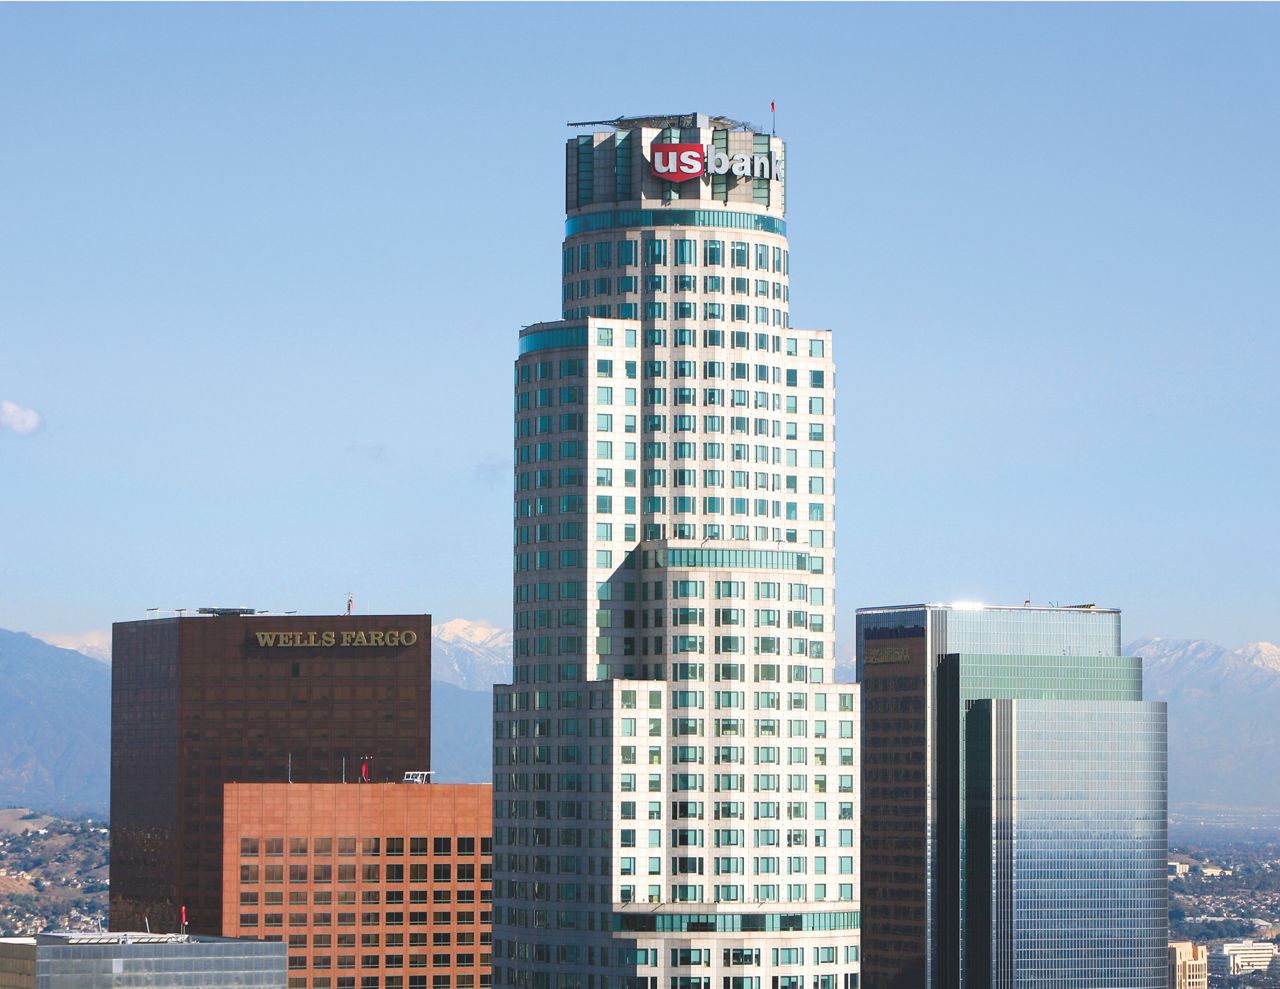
[968,700,1169,989]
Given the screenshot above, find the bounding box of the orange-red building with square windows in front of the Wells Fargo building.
[221,783,493,989]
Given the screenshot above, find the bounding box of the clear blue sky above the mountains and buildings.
[0,4,1280,647]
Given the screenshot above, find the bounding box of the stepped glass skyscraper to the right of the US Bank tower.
[858,605,1169,989]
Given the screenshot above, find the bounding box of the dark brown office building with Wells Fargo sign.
[110,609,431,934]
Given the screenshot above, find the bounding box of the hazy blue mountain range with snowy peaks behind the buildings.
[0,619,1280,814]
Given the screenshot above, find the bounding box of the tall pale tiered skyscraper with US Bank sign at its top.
[494,114,858,989]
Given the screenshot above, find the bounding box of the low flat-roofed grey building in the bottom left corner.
[0,931,285,989]
